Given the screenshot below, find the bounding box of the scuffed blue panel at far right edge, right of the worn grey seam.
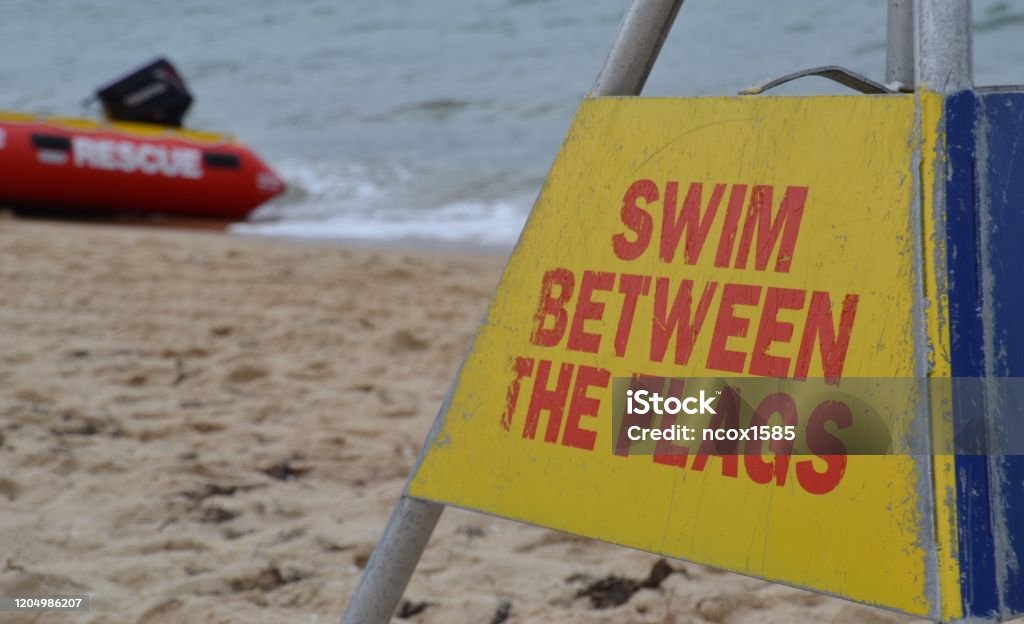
[978,93,1024,616]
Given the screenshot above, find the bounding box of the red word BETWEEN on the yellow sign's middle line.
[530,267,859,382]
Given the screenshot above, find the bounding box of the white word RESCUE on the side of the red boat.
[72,136,203,179]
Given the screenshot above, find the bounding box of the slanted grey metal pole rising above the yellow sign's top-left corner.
[590,0,683,95]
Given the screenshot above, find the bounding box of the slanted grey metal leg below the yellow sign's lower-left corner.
[341,494,444,624]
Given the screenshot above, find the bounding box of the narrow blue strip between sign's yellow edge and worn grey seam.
[945,91,998,617]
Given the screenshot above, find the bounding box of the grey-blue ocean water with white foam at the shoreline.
[0,0,1024,245]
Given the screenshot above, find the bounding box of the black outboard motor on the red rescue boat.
[96,58,193,128]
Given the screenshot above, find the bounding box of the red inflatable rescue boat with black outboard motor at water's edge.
[0,59,285,219]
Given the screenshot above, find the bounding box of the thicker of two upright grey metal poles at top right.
[914,0,974,93]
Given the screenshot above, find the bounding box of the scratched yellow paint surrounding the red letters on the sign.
[409,95,937,616]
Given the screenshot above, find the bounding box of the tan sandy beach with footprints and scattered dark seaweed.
[0,220,921,624]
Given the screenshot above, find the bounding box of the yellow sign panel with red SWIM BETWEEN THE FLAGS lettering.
[409,95,940,616]
